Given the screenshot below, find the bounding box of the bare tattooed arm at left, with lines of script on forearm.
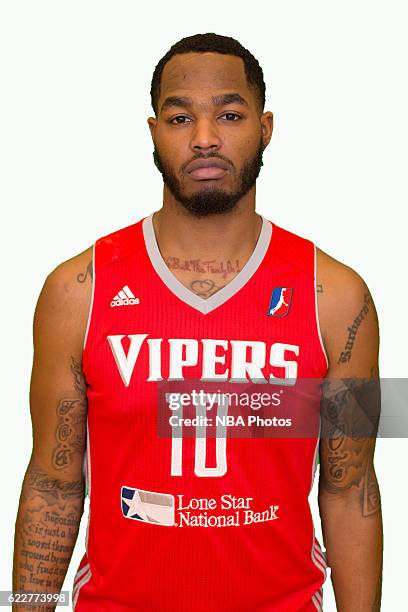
[13,249,92,611]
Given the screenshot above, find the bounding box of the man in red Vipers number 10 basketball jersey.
[14,34,382,612]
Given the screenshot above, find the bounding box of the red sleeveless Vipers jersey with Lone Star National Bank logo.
[72,214,328,612]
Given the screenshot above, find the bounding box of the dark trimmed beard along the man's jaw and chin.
[153,139,264,217]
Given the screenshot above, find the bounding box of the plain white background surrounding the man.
[0,0,408,612]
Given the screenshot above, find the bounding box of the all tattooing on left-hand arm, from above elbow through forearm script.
[13,356,87,612]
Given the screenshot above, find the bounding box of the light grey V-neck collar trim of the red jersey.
[142,212,272,314]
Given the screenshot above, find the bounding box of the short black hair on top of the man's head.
[150,32,265,117]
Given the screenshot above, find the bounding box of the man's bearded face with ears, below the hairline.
[148,53,272,217]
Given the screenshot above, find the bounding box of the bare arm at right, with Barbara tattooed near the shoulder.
[317,250,383,612]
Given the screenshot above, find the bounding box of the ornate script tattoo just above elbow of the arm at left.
[52,356,87,470]
